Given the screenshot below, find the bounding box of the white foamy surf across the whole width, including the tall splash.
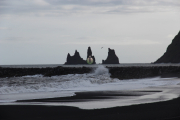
[0,66,179,101]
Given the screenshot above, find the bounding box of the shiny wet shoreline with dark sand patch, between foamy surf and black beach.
[0,79,180,110]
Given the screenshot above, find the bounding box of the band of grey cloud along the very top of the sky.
[0,0,180,15]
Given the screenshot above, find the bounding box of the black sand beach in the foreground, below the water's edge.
[0,91,180,120]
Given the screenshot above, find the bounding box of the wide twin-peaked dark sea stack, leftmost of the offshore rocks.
[65,50,87,65]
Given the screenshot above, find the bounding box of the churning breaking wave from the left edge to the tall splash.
[0,66,119,94]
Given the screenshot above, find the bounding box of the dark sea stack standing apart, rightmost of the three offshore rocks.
[102,48,119,64]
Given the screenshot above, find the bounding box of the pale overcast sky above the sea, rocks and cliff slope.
[0,0,180,65]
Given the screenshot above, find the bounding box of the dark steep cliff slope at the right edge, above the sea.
[154,31,180,63]
